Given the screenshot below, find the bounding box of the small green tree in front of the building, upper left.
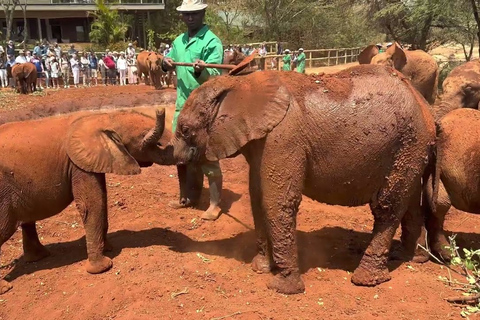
[89,0,129,45]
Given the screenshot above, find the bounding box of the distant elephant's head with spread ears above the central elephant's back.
[358,42,407,70]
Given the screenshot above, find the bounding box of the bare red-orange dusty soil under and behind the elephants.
[0,86,480,320]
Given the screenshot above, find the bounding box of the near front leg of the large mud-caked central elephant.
[257,155,305,294]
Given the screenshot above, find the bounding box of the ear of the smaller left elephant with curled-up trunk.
[66,114,140,175]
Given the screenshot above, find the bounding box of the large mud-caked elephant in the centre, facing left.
[174,65,435,294]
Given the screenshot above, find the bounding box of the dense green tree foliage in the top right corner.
[352,0,480,54]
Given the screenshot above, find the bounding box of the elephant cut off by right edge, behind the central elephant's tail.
[421,109,480,260]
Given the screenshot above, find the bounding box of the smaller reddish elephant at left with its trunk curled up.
[0,107,173,294]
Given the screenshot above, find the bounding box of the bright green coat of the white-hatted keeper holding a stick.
[167,25,223,132]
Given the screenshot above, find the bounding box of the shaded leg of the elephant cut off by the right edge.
[426,181,452,261]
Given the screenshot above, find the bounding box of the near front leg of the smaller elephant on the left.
[72,168,113,273]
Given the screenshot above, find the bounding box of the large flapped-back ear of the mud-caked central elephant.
[206,78,291,161]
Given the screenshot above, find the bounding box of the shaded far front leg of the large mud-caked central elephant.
[249,154,273,273]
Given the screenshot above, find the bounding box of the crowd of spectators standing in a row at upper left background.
[0,41,163,89]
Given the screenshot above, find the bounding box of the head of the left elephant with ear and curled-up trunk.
[66,108,174,175]
